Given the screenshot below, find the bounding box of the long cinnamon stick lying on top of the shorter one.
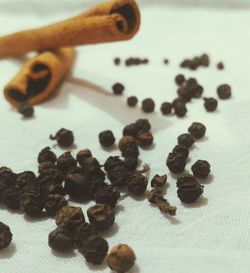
[0,0,140,58]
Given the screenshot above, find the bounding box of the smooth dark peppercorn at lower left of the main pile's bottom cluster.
[49,227,75,252]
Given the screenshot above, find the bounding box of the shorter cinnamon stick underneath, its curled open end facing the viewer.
[4,48,75,107]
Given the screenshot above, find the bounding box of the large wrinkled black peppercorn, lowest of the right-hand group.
[176,174,204,203]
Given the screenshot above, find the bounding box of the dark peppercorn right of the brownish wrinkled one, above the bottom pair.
[87,204,115,230]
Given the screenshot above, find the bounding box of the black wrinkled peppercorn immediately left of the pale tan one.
[78,235,109,265]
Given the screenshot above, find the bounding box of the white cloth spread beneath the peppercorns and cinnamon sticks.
[0,0,250,273]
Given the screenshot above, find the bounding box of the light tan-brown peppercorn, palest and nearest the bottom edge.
[107,244,136,273]
